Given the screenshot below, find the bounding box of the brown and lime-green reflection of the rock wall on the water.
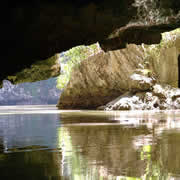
[59,112,180,180]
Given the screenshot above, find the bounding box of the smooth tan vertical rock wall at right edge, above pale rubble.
[149,34,180,87]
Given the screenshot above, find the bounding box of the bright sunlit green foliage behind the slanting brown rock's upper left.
[57,43,100,89]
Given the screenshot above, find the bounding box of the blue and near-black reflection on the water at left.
[0,107,62,180]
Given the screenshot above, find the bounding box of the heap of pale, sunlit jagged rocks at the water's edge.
[102,84,180,110]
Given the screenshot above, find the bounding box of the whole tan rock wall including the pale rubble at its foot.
[58,29,180,110]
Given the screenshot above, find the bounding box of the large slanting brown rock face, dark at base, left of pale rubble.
[58,45,147,109]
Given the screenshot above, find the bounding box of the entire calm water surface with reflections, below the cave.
[0,106,180,180]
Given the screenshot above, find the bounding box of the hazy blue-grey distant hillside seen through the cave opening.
[0,78,61,105]
